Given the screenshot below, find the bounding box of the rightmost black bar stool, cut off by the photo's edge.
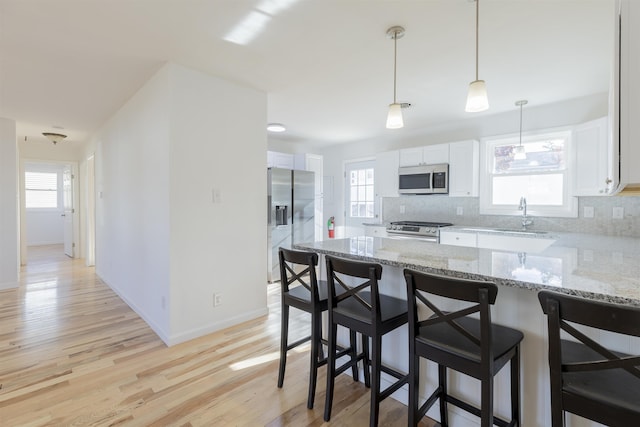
[538,291,640,427]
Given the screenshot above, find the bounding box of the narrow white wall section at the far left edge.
[0,118,19,290]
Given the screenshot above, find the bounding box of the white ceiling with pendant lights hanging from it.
[0,0,614,150]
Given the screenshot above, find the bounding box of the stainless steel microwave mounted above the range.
[398,163,449,194]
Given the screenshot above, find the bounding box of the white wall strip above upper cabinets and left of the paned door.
[320,93,608,237]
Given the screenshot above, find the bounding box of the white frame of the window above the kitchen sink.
[479,127,578,218]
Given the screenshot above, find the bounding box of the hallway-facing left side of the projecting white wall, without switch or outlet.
[93,64,171,341]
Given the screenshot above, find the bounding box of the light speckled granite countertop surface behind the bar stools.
[294,234,640,307]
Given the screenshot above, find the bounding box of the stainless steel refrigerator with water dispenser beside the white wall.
[267,168,315,283]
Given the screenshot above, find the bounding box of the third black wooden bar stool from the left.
[404,269,523,427]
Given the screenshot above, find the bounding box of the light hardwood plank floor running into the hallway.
[0,245,433,427]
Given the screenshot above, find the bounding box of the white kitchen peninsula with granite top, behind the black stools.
[295,234,640,427]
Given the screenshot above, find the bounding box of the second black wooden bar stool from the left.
[324,255,408,426]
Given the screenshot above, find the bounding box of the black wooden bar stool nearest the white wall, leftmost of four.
[278,248,358,409]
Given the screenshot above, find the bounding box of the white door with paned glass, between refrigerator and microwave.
[345,160,376,237]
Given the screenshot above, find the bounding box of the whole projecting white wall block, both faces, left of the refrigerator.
[93,64,267,345]
